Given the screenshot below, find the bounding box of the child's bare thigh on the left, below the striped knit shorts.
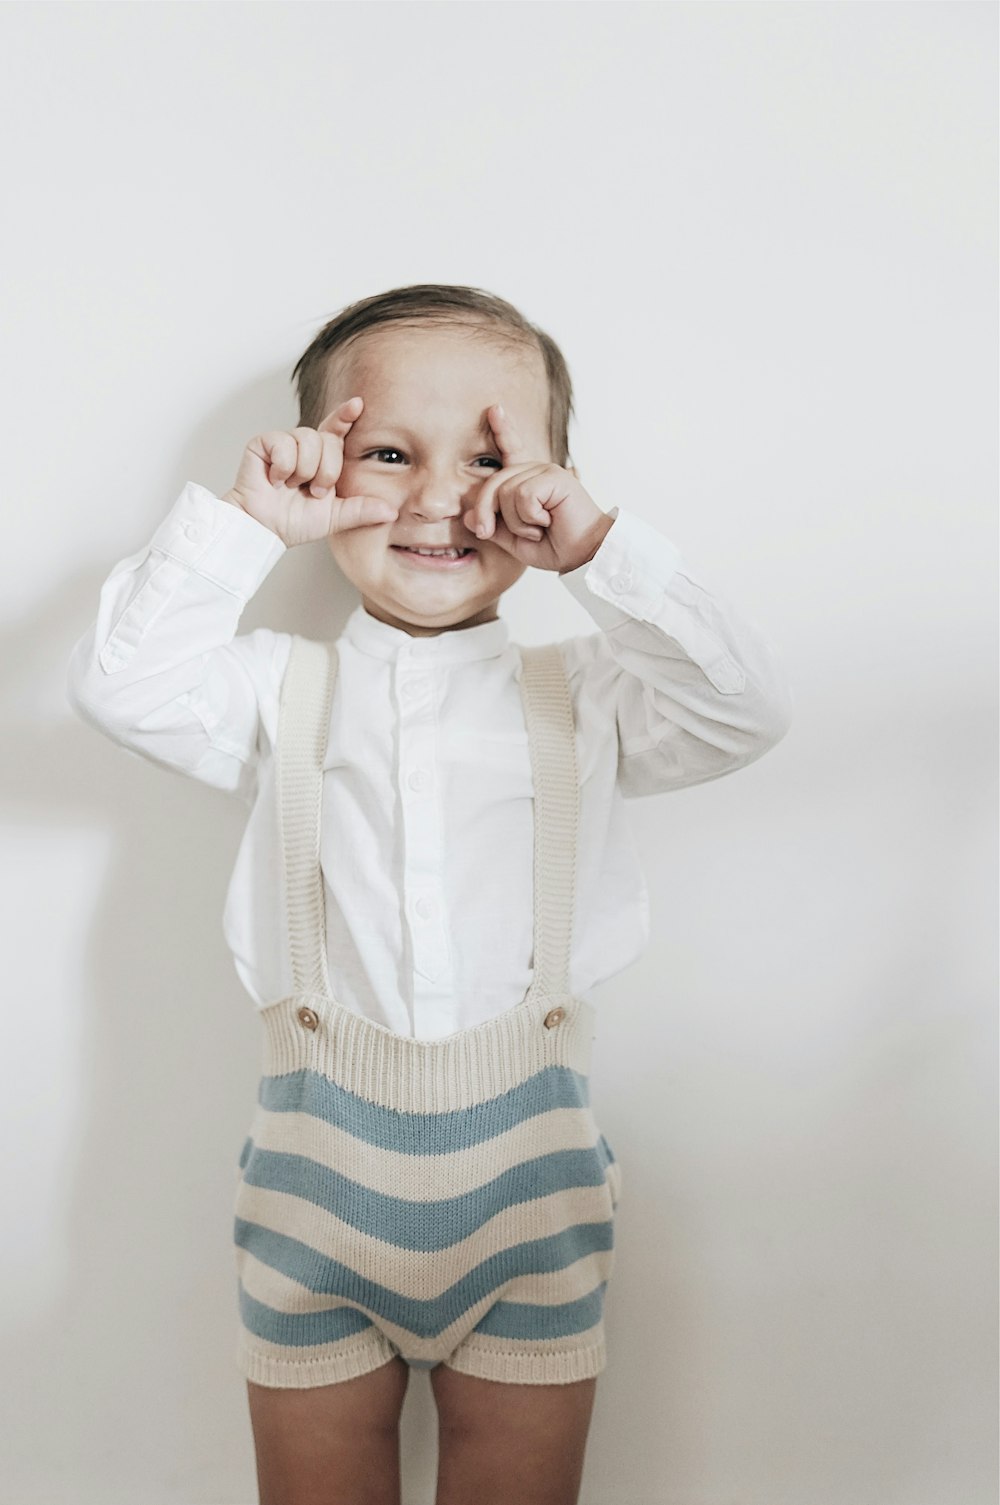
[247,1356,410,1505]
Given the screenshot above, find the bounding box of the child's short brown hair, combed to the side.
[292,283,572,467]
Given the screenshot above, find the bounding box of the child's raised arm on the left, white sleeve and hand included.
[66,399,396,798]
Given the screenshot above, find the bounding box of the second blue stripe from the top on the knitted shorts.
[244,1139,608,1252]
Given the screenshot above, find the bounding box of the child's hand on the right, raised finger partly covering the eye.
[462,405,614,575]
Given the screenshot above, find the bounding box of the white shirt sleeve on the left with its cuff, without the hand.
[66,482,291,801]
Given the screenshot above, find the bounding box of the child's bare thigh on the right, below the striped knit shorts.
[431,1364,598,1505]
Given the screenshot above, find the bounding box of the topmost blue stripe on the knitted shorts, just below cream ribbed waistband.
[258,1066,590,1154]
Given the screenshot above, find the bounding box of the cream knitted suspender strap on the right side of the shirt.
[520,643,580,995]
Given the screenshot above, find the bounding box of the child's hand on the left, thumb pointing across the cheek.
[221,397,399,548]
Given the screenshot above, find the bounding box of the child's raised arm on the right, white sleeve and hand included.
[465,405,792,796]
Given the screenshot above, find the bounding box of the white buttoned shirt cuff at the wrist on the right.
[559,507,684,631]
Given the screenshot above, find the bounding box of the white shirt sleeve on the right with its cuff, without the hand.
[559,507,792,798]
